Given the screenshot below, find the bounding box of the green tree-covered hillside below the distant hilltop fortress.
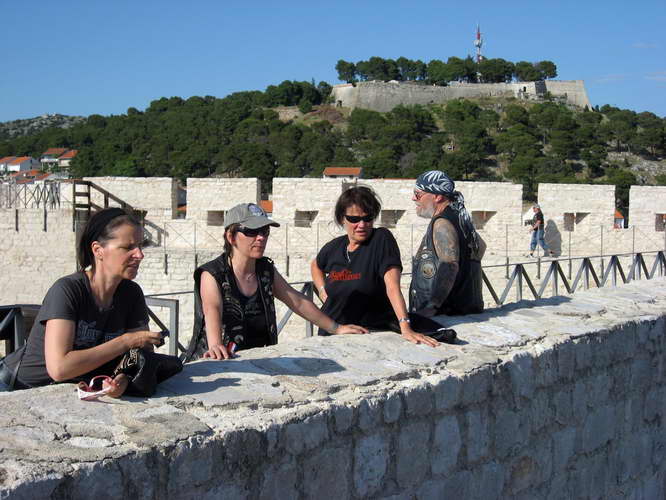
[0,81,666,208]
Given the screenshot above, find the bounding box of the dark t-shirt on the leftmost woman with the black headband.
[5,272,148,387]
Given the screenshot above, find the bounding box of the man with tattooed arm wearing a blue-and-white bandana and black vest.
[409,170,486,317]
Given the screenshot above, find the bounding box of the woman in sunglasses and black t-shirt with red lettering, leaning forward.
[310,186,438,347]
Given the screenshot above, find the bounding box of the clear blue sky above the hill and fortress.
[0,0,666,121]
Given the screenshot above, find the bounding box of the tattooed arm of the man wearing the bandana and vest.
[419,219,460,316]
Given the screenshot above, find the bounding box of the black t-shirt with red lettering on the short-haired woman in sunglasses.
[317,227,402,334]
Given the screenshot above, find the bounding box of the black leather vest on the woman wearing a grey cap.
[184,254,277,361]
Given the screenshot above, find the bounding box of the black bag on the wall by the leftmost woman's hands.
[113,348,183,397]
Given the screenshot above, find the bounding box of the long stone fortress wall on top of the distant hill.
[332,80,592,112]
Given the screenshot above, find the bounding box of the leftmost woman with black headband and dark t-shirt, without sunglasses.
[0,208,162,397]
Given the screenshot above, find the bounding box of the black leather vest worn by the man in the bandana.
[409,206,483,315]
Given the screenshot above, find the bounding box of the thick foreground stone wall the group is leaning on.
[0,279,666,500]
